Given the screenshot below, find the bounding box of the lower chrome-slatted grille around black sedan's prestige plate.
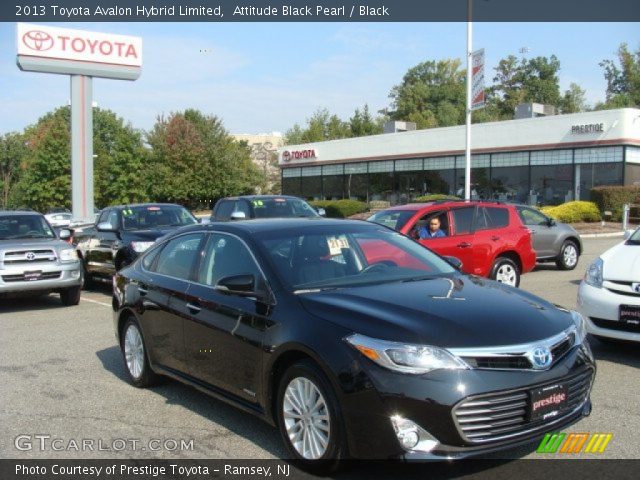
[453,369,593,443]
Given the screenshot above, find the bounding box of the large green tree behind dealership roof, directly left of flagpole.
[387,59,466,128]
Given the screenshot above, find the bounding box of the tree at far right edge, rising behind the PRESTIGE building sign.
[596,43,640,109]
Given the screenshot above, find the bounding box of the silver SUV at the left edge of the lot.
[0,211,82,305]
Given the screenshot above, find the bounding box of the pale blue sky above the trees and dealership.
[0,22,640,134]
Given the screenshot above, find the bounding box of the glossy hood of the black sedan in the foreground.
[299,276,573,348]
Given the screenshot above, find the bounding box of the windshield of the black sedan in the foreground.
[260,225,455,293]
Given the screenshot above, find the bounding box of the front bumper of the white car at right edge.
[578,281,640,342]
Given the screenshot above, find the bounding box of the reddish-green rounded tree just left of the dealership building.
[146,109,263,208]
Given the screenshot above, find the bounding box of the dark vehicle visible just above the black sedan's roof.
[211,195,324,222]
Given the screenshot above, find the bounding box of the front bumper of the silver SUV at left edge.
[0,261,82,294]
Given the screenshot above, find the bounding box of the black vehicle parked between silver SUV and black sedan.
[73,203,197,281]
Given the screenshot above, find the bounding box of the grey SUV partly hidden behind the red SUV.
[516,205,582,270]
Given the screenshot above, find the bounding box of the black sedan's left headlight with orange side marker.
[345,333,469,374]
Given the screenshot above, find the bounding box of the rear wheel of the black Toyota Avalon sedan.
[120,317,158,388]
